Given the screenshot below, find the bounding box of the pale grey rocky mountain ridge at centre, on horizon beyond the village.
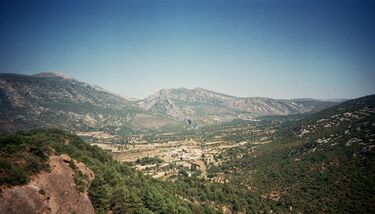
[137,88,335,124]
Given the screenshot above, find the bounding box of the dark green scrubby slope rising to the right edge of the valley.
[209,95,375,213]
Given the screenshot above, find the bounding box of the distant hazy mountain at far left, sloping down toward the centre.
[0,73,179,134]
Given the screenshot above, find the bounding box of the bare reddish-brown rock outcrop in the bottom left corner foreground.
[0,155,95,214]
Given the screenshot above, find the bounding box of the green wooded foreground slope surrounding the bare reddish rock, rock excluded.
[0,130,274,213]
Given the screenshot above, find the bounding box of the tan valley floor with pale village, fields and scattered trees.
[78,121,275,183]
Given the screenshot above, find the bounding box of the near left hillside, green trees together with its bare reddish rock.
[0,130,223,214]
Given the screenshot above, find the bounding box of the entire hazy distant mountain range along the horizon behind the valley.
[0,72,337,135]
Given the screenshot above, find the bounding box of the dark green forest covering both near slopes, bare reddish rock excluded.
[0,95,375,213]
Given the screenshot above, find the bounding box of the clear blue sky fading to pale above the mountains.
[0,0,375,99]
